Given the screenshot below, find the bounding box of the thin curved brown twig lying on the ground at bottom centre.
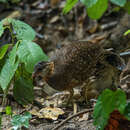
[52,108,93,130]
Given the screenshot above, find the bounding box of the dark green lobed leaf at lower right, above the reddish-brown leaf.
[93,89,126,130]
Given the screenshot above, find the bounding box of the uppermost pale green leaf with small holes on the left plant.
[11,19,35,41]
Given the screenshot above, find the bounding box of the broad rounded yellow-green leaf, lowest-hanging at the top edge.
[87,0,108,19]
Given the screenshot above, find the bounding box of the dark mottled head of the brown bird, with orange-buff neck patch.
[32,61,54,86]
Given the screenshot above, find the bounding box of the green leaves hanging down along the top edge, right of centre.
[63,0,127,19]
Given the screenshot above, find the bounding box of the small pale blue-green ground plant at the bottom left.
[12,112,32,130]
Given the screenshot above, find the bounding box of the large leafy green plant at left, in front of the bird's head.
[0,19,48,100]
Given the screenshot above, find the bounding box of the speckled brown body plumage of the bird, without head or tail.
[47,41,103,90]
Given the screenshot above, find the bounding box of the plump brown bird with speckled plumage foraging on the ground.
[33,41,124,99]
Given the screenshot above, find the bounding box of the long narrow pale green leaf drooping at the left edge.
[0,44,19,91]
